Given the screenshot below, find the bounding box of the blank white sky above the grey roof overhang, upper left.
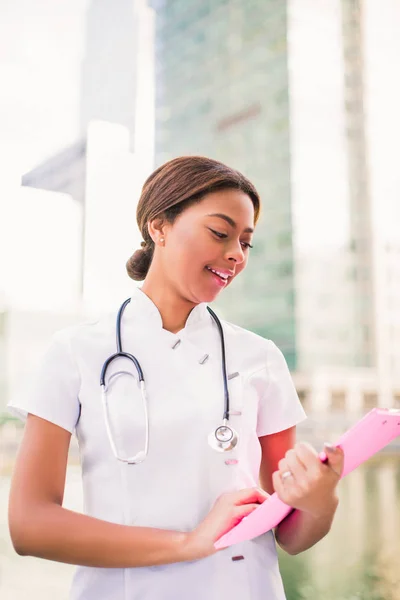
[0,0,89,177]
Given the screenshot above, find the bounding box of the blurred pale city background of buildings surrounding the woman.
[0,0,400,600]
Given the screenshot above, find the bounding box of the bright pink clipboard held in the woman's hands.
[214,408,400,550]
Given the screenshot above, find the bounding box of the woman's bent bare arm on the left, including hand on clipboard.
[9,415,265,568]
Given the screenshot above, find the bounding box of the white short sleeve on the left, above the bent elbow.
[7,331,80,433]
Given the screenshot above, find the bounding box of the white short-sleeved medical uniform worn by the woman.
[10,289,305,600]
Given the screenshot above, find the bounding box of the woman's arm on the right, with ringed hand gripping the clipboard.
[260,427,343,554]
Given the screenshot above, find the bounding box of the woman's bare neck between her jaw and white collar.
[141,275,195,333]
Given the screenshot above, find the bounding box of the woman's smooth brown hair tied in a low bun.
[126,156,260,281]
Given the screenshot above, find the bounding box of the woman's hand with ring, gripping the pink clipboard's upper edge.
[272,442,344,518]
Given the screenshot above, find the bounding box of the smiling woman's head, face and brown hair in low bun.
[123,156,260,329]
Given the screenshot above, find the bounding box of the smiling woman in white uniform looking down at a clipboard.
[9,157,343,600]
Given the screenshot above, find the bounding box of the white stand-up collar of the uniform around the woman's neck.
[128,288,209,335]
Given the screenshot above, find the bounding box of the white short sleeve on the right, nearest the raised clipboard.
[257,341,306,437]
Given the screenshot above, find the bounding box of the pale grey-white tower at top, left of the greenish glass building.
[80,0,154,152]
